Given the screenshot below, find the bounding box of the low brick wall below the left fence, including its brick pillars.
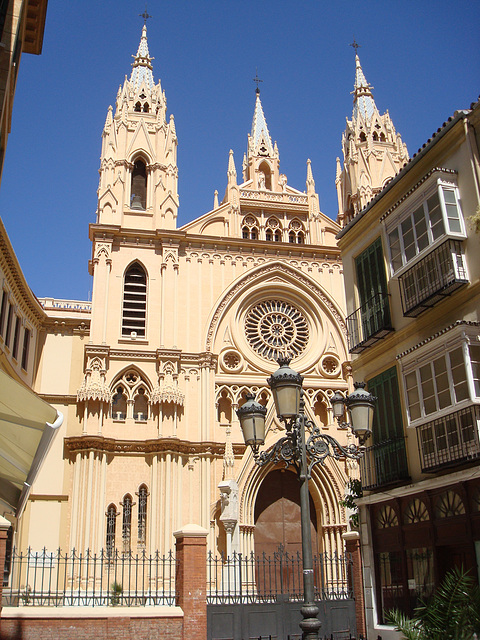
[0,518,208,640]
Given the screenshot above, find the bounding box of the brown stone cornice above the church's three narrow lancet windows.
[64,435,246,458]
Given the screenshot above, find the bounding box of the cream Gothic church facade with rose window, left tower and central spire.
[16,27,372,564]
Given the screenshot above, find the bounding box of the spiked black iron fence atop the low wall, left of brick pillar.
[2,549,176,607]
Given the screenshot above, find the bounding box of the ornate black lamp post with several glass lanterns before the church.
[237,357,376,640]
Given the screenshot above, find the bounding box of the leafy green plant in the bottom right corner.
[385,568,480,640]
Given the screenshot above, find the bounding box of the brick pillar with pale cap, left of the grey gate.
[173,524,208,640]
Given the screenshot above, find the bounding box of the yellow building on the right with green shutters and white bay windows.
[338,90,480,639]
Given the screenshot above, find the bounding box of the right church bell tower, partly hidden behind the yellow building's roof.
[335,48,408,226]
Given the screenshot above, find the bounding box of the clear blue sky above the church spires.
[0,0,480,299]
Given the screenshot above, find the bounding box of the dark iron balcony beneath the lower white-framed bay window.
[417,405,480,473]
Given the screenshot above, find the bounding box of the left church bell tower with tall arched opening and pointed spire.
[97,25,178,230]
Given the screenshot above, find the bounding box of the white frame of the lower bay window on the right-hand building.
[399,325,480,428]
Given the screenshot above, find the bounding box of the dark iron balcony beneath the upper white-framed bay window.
[399,239,468,318]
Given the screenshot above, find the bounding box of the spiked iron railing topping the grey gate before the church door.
[207,547,353,604]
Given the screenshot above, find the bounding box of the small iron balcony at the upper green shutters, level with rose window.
[347,293,393,353]
